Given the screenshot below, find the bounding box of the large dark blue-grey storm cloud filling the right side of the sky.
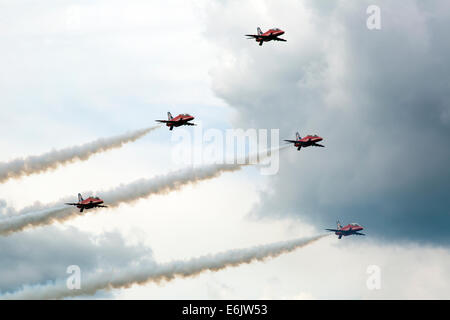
[206,0,450,244]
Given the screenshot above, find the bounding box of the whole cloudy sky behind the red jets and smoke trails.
[0,0,450,299]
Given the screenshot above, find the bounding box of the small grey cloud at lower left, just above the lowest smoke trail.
[0,226,153,293]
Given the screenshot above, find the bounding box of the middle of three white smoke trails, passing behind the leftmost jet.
[0,148,284,235]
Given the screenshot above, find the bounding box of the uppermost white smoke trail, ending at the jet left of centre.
[0,126,160,183]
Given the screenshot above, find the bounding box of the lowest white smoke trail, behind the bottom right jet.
[0,235,327,299]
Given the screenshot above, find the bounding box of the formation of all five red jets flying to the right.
[62,27,365,239]
